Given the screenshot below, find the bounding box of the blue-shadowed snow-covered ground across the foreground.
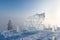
[0,30,60,40]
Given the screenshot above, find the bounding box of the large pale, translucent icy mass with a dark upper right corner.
[25,13,45,31]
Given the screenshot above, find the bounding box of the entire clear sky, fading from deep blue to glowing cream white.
[0,0,60,25]
